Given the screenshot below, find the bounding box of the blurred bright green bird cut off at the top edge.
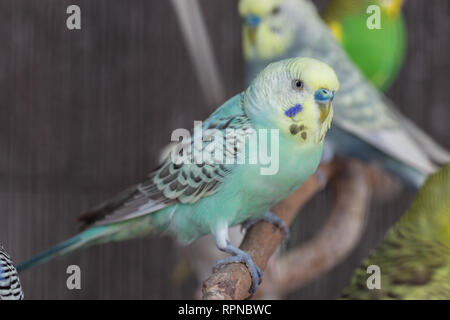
[323,0,406,90]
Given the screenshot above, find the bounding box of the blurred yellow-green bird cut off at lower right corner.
[342,165,450,300]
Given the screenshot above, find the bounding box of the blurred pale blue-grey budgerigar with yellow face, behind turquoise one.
[239,0,450,189]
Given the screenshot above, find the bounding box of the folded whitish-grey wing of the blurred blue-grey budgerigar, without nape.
[323,42,440,175]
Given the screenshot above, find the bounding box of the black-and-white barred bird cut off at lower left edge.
[0,246,23,300]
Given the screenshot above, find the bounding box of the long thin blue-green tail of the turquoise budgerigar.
[17,226,106,272]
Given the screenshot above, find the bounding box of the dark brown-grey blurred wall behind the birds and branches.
[0,0,450,299]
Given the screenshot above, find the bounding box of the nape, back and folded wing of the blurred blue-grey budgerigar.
[280,7,450,175]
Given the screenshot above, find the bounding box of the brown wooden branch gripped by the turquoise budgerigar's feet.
[202,164,339,300]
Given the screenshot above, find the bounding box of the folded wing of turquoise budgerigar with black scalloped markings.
[79,96,254,227]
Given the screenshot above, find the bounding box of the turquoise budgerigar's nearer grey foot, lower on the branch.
[213,241,263,297]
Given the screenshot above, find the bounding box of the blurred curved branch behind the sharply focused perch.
[256,161,373,299]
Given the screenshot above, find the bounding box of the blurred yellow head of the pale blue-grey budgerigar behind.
[239,0,294,60]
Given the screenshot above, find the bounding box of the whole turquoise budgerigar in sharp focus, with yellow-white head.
[19,58,339,293]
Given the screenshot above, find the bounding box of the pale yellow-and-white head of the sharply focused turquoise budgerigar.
[245,58,339,143]
